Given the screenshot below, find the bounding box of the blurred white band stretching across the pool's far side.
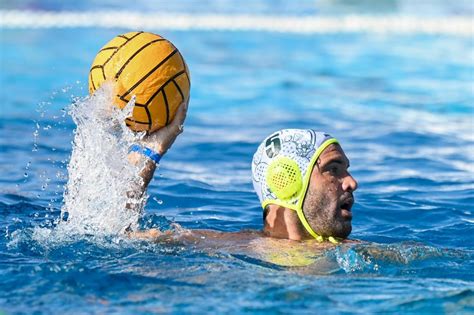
[0,10,474,36]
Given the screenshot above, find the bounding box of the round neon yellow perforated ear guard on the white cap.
[266,156,303,201]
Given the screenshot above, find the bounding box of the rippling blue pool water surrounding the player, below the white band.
[0,1,474,314]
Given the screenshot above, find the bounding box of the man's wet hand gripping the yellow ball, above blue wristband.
[141,101,188,156]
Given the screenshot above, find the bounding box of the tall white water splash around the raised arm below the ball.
[58,84,147,235]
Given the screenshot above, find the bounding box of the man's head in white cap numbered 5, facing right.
[252,129,357,240]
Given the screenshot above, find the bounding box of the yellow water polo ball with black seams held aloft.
[89,32,191,132]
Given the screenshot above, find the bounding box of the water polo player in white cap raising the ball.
[128,127,357,243]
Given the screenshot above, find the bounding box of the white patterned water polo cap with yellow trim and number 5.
[252,129,338,242]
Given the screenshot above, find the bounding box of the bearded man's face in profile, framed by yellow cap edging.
[303,144,357,238]
